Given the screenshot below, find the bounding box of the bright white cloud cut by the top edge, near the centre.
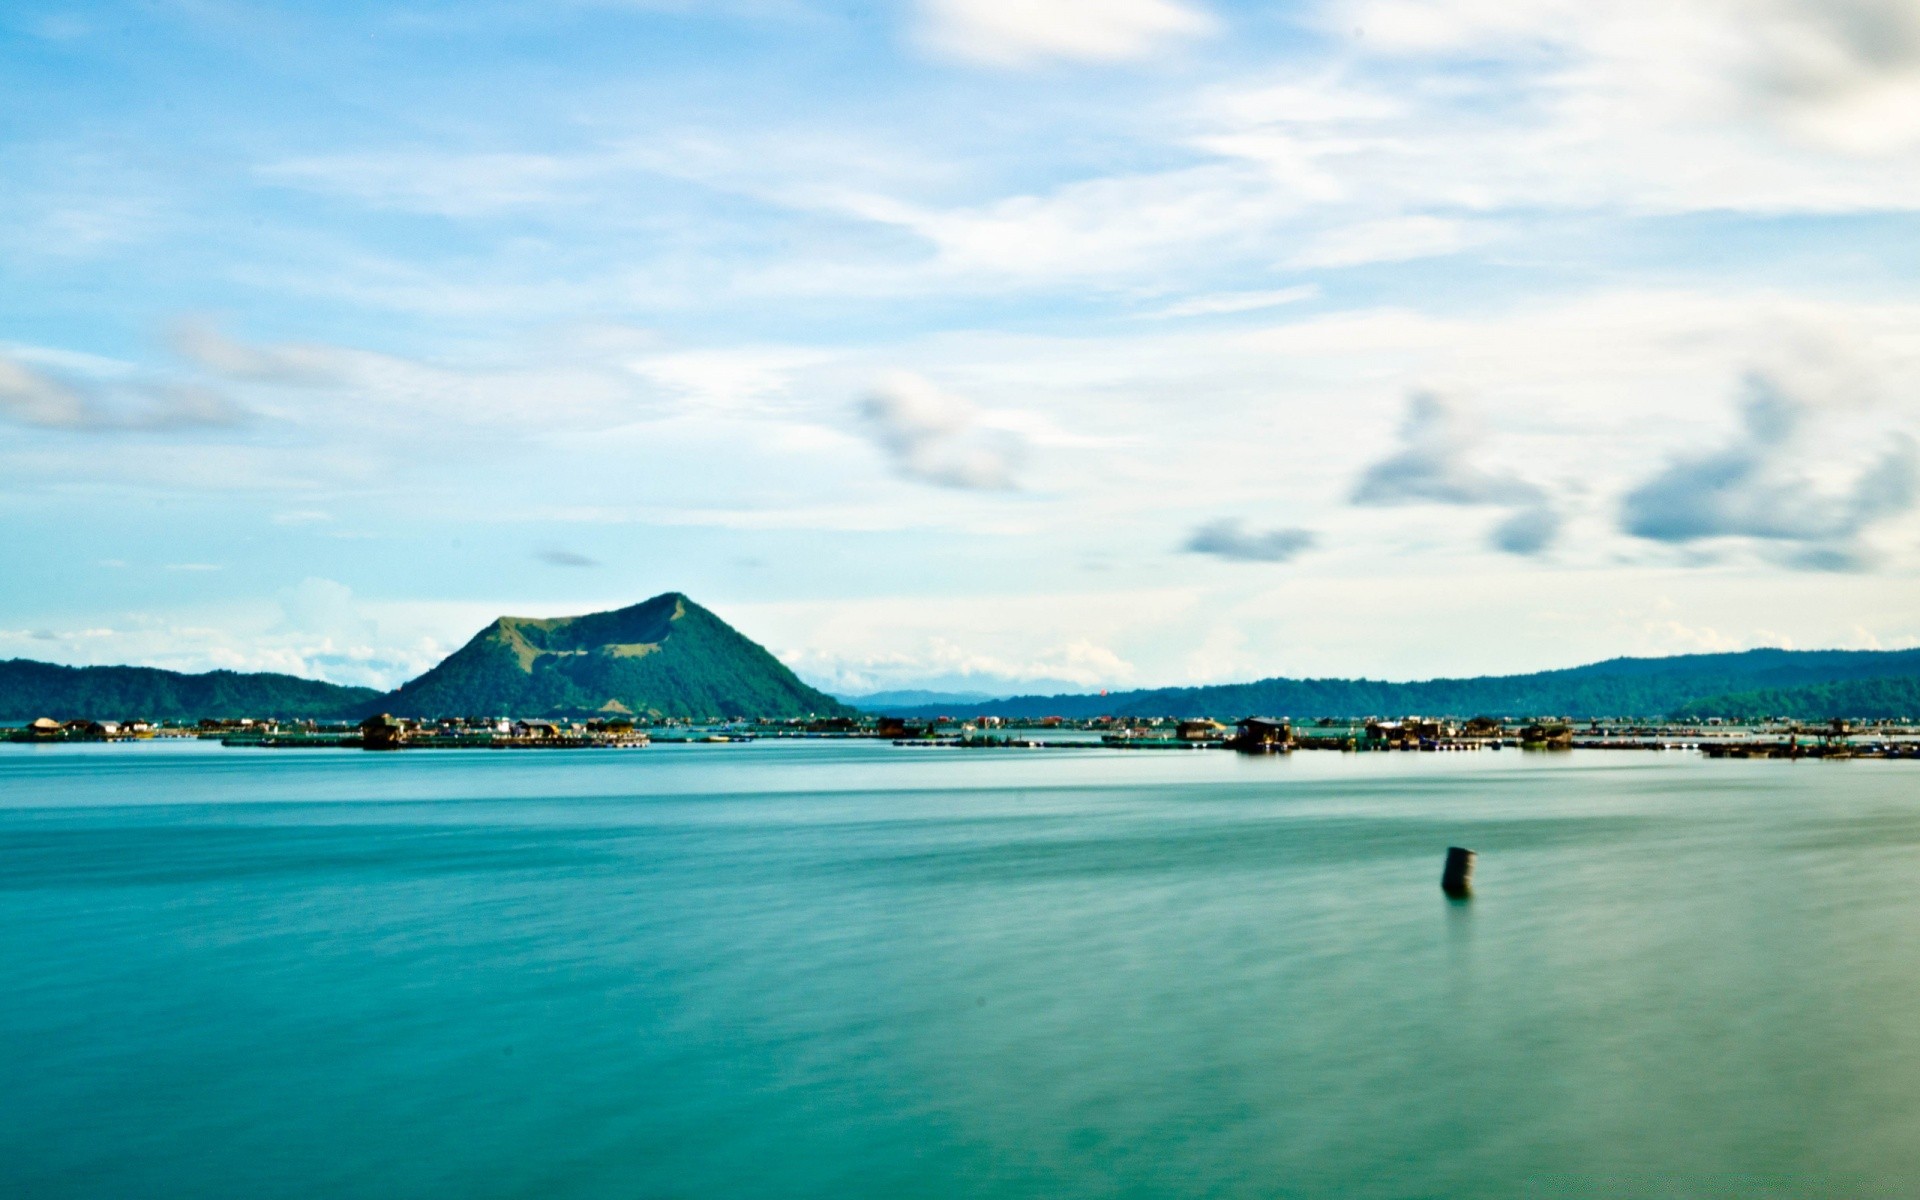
[922,0,1215,67]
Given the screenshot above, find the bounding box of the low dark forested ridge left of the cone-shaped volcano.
[0,659,380,720]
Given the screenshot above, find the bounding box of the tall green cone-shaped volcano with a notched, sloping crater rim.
[365,591,854,718]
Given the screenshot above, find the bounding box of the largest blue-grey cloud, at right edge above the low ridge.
[1620,374,1920,570]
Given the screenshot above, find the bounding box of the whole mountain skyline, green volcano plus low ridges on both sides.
[15,618,1920,722]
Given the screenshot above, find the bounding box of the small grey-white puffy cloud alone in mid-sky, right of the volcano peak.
[860,372,1025,492]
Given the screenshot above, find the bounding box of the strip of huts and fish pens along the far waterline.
[4,712,1920,760]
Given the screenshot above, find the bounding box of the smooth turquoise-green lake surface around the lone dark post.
[0,741,1920,1198]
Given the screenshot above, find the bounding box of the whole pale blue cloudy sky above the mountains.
[0,0,1920,693]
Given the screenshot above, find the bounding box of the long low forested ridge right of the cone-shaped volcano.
[864,649,1920,720]
